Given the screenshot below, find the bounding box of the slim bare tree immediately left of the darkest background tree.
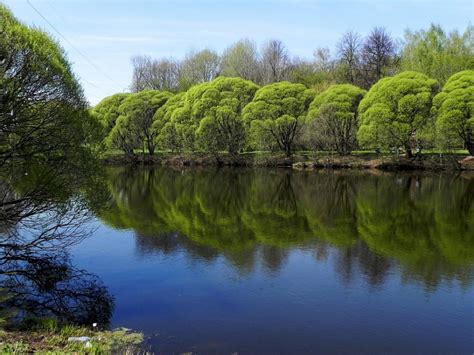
[337,31,362,84]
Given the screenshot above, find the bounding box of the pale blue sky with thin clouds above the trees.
[0,0,474,104]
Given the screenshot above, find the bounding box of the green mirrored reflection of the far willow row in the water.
[99,168,474,291]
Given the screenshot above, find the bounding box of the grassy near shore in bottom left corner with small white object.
[0,321,143,354]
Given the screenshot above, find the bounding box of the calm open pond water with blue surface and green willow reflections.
[72,169,474,354]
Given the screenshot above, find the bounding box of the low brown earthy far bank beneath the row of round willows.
[102,153,474,171]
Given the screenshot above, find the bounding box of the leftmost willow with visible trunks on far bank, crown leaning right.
[107,90,172,155]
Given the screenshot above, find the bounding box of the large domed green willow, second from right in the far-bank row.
[357,72,438,157]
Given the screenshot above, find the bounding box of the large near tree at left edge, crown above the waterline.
[0,4,96,164]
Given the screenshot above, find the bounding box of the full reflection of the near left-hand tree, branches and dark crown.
[0,162,114,327]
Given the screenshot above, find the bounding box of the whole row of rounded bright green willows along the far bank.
[92,70,474,157]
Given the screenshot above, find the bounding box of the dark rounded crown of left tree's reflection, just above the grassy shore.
[0,250,113,327]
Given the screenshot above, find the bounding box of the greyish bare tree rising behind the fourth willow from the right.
[262,40,290,84]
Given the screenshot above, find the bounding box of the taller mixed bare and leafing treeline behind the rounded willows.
[131,25,474,92]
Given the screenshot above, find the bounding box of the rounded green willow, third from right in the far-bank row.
[306,84,366,155]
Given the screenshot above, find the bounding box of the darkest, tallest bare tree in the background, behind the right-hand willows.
[362,27,398,88]
